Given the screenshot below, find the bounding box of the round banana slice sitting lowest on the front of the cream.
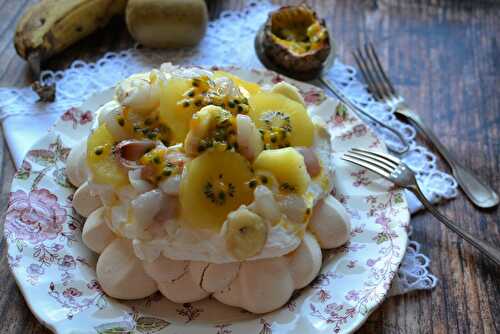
[224,207,267,261]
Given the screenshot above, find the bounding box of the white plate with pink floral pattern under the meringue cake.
[5,68,409,334]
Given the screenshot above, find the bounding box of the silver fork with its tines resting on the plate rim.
[342,148,500,265]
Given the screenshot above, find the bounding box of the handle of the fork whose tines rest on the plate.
[408,185,500,265]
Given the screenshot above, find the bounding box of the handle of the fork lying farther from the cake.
[395,108,499,208]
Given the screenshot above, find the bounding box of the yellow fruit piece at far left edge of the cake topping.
[87,124,128,187]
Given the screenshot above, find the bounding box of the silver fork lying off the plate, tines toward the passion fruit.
[353,43,499,208]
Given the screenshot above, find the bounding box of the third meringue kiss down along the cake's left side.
[82,207,116,254]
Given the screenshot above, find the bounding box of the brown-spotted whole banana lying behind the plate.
[14,0,127,75]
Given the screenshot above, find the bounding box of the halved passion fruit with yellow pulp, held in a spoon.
[255,5,332,79]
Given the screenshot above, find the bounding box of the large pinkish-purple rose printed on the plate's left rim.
[5,189,66,244]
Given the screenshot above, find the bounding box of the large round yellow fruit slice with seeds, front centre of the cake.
[180,150,253,231]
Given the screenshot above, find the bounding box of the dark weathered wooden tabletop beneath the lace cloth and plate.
[0,0,500,334]
